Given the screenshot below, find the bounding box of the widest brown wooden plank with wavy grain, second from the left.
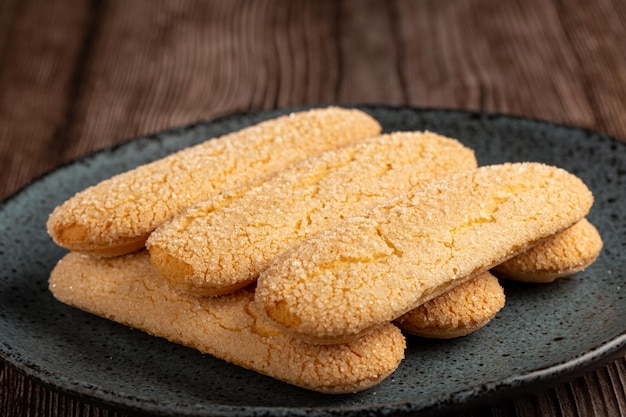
[59,0,348,159]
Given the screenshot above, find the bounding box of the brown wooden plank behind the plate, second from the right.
[397,0,593,126]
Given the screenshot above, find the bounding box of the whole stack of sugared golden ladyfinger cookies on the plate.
[47,107,602,393]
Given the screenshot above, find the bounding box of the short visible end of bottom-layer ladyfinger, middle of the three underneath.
[394,272,506,339]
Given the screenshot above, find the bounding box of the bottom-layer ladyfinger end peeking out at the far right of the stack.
[493,219,603,282]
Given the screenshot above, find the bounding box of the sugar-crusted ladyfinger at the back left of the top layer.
[47,107,381,256]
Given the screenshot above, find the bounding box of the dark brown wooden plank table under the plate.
[0,0,626,417]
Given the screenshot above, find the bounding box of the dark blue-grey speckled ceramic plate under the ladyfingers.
[0,106,626,416]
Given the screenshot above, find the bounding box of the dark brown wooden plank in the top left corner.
[0,1,91,198]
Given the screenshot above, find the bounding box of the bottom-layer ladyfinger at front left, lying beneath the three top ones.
[49,251,406,393]
